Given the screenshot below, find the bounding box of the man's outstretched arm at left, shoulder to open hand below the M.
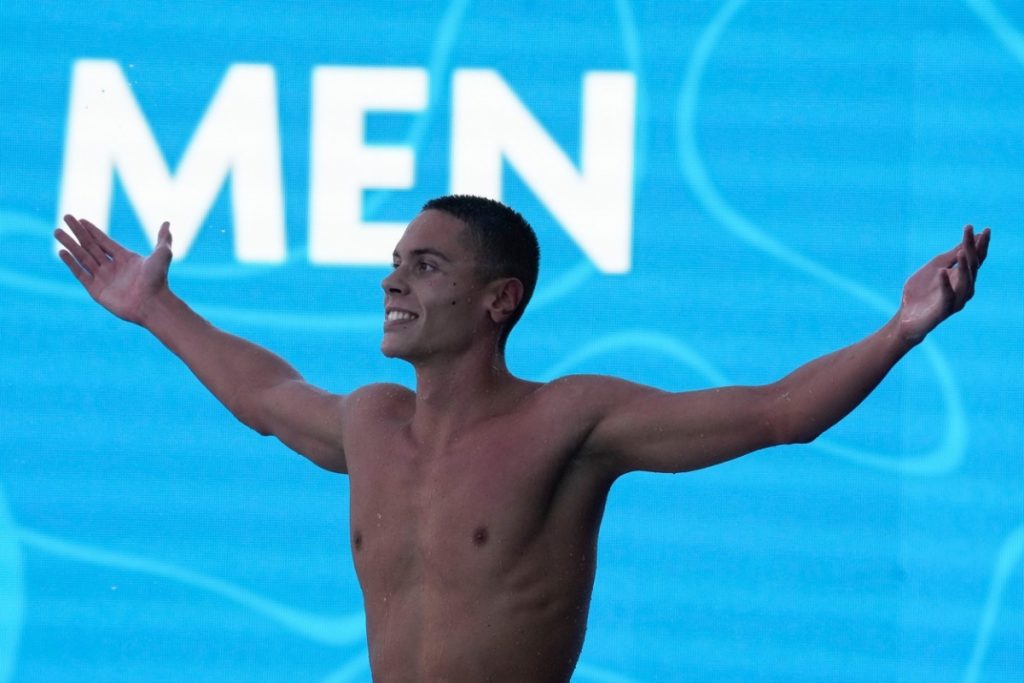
[55,216,345,472]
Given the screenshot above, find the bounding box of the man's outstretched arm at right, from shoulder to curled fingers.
[584,226,990,474]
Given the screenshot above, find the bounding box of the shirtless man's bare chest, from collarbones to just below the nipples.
[349,421,567,581]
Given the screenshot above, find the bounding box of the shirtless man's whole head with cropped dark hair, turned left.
[382,196,540,359]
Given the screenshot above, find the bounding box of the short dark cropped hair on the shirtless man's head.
[423,195,541,349]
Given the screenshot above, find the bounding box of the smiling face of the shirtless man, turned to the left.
[381,210,488,361]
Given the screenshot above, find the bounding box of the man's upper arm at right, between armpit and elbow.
[594,387,776,473]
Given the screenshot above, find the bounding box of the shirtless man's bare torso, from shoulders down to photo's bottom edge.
[344,380,612,683]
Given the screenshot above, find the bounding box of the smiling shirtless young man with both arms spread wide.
[56,197,989,683]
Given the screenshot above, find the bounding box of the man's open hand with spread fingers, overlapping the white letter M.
[54,215,171,325]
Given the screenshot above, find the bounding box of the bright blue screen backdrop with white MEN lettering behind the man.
[0,0,1024,683]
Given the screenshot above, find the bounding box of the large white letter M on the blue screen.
[59,59,285,262]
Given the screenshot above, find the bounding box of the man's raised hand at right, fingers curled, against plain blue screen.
[897,225,991,344]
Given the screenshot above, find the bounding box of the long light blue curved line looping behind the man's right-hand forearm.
[677,0,967,474]
